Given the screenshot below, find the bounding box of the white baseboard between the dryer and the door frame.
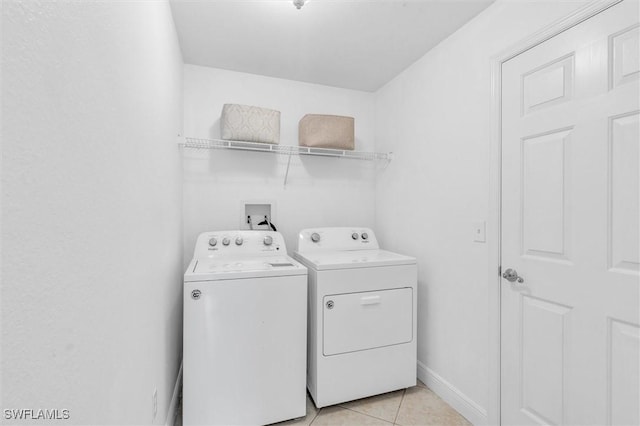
[418,361,488,425]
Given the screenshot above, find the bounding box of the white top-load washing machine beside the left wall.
[182,231,307,425]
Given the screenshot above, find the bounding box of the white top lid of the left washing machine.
[184,256,307,282]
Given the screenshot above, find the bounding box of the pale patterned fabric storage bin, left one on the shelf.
[220,104,280,144]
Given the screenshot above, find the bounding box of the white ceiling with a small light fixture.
[171,0,494,91]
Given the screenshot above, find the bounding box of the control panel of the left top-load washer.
[193,231,287,258]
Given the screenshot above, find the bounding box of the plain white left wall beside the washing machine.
[0,0,183,424]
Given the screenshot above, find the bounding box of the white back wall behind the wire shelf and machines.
[184,65,376,263]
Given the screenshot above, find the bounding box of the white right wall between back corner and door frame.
[375,0,586,422]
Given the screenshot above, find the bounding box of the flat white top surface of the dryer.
[294,250,416,271]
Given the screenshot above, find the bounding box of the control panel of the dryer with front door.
[298,227,380,253]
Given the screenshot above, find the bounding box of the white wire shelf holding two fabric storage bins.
[179,137,392,161]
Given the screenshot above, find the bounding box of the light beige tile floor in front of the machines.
[174,380,471,426]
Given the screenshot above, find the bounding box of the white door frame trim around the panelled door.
[487,0,623,425]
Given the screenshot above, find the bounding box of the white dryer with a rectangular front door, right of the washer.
[294,228,417,407]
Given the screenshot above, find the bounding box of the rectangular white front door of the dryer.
[323,287,413,355]
